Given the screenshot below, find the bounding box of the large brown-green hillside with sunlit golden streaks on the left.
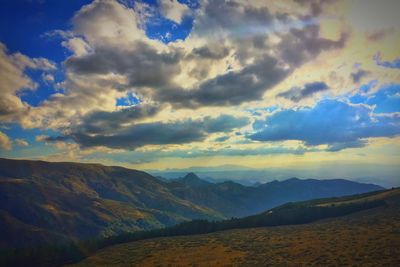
[0,159,223,247]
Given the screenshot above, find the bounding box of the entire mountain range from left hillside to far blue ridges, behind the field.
[0,159,382,247]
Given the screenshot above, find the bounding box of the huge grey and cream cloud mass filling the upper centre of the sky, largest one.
[25,0,345,132]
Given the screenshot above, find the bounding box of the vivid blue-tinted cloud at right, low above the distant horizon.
[248,100,400,151]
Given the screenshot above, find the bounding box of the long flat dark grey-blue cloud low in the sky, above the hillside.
[69,115,249,149]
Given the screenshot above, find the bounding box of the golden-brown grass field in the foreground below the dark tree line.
[69,190,400,267]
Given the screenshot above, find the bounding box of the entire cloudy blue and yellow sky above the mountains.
[0,0,400,185]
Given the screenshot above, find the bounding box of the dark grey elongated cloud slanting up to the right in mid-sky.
[156,56,289,107]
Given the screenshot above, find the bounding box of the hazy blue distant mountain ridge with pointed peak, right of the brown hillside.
[168,174,384,217]
